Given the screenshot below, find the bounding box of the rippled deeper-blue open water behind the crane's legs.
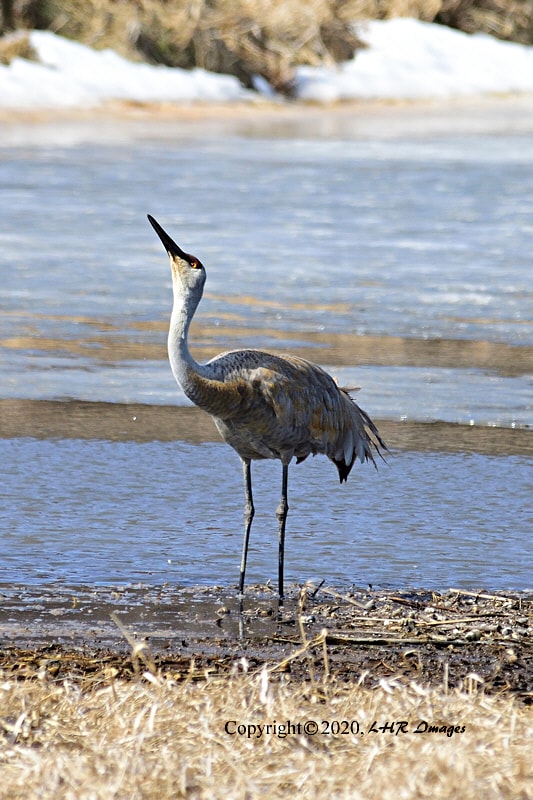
[0,439,533,589]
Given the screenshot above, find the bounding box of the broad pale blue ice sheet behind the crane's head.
[0,136,533,346]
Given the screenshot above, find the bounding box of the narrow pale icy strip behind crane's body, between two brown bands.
[4,357,533,427]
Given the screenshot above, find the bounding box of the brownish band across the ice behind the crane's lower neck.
[5,324,533,377]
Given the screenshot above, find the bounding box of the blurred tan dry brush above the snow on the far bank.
[0,0,533,95]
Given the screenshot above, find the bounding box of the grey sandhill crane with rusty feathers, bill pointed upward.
[148,215,387,601]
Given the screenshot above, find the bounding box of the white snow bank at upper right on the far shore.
[297,18,533,102]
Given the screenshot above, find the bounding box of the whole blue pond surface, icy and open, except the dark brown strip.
[0,109,533,589]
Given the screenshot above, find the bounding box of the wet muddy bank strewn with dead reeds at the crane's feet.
[0,586,533,703]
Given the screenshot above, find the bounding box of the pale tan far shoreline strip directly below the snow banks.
[0,94,533,147]
